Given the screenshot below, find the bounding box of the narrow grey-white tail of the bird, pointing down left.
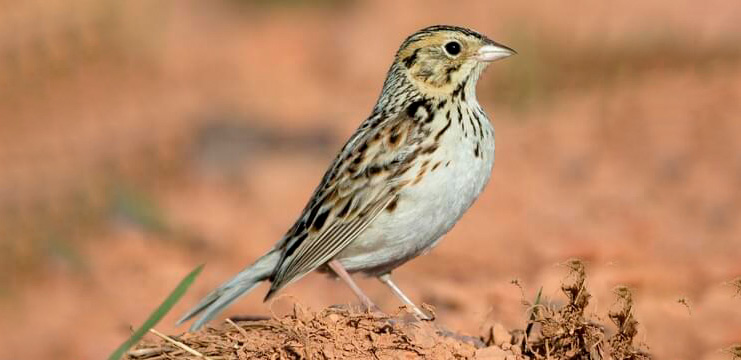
[177,250,280,331]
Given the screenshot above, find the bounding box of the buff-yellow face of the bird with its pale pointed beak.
[397,29,514,94]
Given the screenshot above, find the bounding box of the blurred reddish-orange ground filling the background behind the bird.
[0,0,741,359]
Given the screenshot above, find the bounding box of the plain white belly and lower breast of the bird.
[336,114,494,275]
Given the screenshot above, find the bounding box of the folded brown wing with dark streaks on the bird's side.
[266,105,430,299]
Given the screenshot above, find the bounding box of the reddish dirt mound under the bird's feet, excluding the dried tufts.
[129,305,518,360]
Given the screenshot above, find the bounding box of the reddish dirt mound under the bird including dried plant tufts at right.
[128,260,650,360]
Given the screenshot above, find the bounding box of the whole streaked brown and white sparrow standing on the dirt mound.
[177,25,516,331]
